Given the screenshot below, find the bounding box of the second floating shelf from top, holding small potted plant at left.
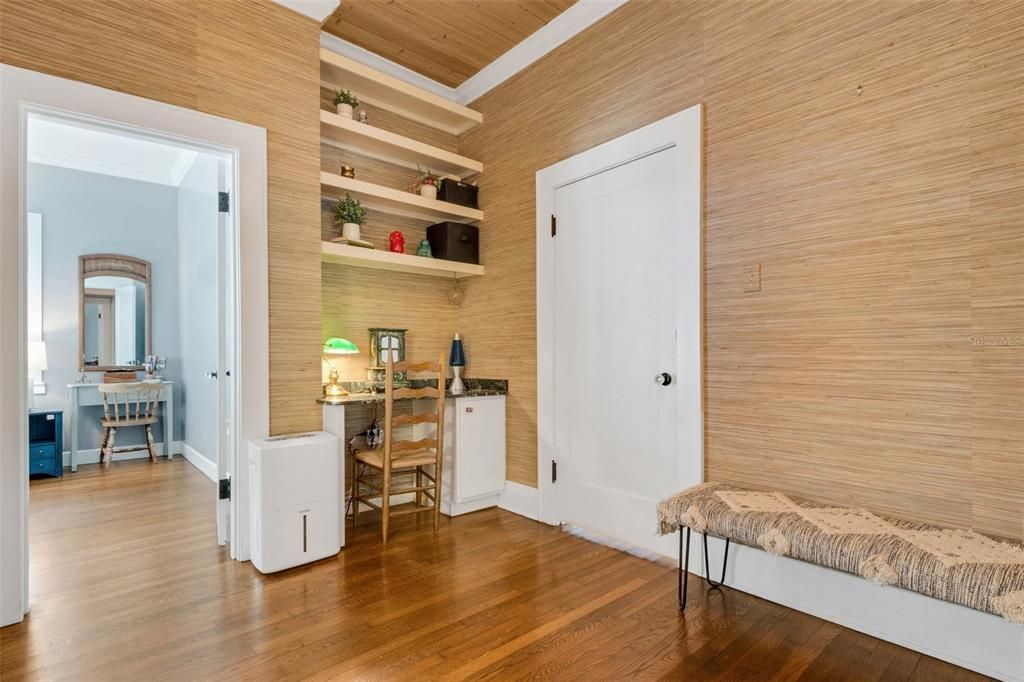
[321,110,483,178]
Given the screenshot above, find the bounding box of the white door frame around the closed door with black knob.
[537,104,703,527]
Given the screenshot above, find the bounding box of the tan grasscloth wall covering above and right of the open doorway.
[0,0,321,433]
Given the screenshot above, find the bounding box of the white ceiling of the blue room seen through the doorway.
[28,116,199,187]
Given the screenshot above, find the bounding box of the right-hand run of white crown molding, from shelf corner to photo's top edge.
[455,0,627,104]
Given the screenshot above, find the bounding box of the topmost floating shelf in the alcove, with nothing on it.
[321,47,483,135]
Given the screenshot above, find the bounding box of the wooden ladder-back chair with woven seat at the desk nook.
[352,353,447,545]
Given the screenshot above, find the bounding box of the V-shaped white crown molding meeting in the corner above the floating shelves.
[321,0,628,109]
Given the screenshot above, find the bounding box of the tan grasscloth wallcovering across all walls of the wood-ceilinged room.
[6,0,1024,539]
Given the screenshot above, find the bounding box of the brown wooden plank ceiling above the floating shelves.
[324,0,575,87]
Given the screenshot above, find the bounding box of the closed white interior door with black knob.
[552,111,702,554]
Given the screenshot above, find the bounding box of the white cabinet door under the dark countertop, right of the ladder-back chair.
[454,395,505,502]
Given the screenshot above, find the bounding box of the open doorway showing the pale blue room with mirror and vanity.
[24,112,236,604]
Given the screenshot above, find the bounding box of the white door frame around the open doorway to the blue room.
[0,65,270,626]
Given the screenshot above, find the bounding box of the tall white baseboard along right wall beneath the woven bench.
[690,534,1024,682]
